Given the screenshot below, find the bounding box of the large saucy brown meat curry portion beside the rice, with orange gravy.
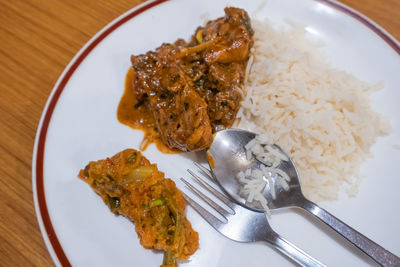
[118,7,253,151]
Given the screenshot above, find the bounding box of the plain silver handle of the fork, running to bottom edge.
[267,232,326,267]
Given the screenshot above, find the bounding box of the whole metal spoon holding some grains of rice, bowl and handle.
[208,129,400,266]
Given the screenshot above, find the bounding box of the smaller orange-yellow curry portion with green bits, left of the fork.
[79,149,198,267]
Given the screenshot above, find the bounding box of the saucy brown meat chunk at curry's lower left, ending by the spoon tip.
[132,41,212,151]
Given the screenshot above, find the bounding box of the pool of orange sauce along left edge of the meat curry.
[117,68,179,154]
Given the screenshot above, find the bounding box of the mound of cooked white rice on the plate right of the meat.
[236,21,390,204]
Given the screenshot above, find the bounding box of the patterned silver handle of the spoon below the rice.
[299,198,400,266]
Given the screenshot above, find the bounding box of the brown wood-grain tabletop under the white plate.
[0,0,400,266]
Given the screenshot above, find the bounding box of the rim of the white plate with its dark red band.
[32,0,400,266]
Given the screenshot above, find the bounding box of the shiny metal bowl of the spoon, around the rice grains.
[208,129,304,212]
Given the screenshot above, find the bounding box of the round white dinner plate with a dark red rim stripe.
[33,0,400,267]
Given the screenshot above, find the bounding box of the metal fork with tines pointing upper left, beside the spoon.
[181,164,326,266]
